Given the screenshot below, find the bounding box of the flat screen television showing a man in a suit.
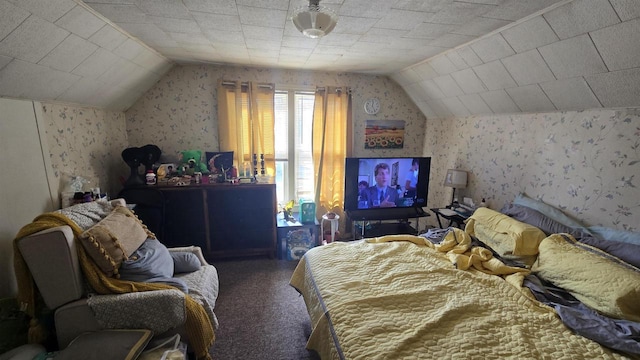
[344,157,431,216]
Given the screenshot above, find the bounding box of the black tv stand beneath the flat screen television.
[346,207,429,238]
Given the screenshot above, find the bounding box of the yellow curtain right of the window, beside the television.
[313,87,352,234]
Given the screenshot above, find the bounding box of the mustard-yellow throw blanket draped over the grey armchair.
[13,213,215,359]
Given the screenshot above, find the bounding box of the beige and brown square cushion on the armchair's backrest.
[80,206,149,277]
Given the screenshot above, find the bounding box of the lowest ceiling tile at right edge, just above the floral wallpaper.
[585,68,640,107]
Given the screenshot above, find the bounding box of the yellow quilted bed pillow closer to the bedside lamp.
[465,208,546,256]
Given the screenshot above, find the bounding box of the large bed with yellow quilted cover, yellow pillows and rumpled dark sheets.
[290,204,640,359]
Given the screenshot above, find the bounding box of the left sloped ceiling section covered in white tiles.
[0,0,173,111]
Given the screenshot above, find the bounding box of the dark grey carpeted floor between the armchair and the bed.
[211,258,319,360]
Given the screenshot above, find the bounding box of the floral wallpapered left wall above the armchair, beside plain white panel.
[42,102,129,204]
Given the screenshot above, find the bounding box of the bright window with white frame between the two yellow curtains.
[275,90,315,208]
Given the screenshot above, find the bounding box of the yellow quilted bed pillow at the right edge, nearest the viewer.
[531,234,640,321]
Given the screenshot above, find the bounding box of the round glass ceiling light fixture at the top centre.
[291,0,338,39]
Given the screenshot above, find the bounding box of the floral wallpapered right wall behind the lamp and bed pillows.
[425,109,640,232]
